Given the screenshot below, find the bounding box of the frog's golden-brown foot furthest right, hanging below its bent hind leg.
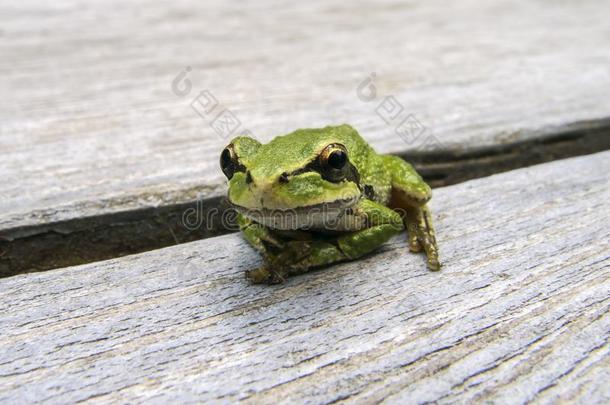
[406,205,441,271]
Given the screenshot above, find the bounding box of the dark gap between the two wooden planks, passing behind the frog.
[0,119,610,277]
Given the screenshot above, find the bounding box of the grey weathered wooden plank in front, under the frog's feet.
[0,152,610,404]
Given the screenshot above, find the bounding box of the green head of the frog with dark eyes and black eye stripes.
[220,125,367,229]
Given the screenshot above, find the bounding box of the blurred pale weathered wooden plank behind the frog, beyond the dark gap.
[0,0,610,234]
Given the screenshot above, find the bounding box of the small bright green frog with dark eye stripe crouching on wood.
[220,125,441,284]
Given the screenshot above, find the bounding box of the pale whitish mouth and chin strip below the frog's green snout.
[232,198,362,231]
